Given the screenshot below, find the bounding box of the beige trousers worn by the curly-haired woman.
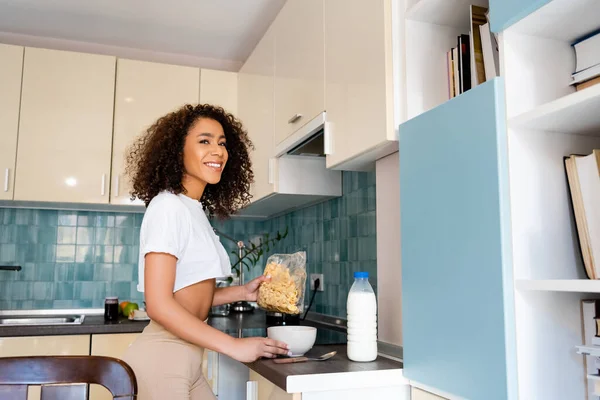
[123,321,216,400]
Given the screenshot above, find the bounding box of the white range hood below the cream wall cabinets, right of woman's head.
[237,112,342,219]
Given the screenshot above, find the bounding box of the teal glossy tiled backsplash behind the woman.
[0,172,377,316]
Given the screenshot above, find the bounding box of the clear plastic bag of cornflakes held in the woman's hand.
[257,251,306,314]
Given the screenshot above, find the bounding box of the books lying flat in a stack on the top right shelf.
[571,31,600,91]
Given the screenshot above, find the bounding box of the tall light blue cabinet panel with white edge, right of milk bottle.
[399,78,512,400]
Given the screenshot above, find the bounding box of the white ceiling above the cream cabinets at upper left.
[0,0,285,70]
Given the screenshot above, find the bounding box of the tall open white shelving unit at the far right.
[499,0,600,399]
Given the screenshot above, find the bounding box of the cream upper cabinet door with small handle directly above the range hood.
[273,0,325,144]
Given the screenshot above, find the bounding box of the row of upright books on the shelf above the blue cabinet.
[446,5,500,98]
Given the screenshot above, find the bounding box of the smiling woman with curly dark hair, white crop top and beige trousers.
[123,104,288,400]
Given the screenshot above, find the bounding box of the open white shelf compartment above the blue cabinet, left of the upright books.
[404,0,488,119]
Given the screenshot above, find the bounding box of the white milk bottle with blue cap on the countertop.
[346,272,377,362]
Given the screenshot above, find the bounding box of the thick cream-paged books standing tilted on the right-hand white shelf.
[564,149,600,279]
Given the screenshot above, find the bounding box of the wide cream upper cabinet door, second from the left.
[14,47,116,203]
